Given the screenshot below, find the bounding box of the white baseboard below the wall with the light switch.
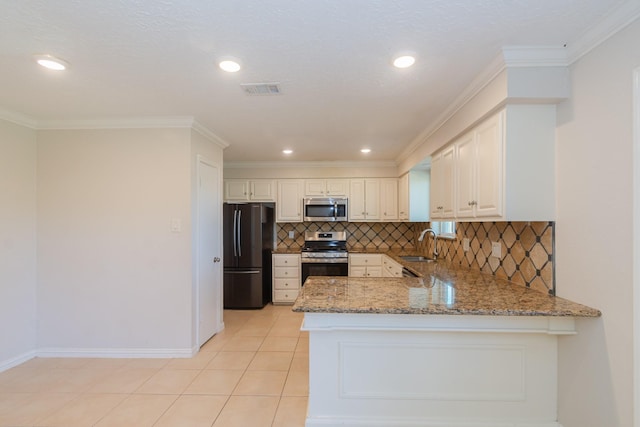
[37,347,198,359]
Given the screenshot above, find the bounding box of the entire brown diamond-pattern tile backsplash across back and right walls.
[276,221,555,295]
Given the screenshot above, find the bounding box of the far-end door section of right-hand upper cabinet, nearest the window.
[430,145,455,219]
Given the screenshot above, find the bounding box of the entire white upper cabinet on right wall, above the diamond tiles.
[431,105,556,221]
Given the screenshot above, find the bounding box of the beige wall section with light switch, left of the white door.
[37,128,192,356]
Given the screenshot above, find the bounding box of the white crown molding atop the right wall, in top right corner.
[567,0,640,64]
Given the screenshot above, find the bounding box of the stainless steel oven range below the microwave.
[301,231,349,285]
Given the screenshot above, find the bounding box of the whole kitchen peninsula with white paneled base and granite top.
[293,254,600,427]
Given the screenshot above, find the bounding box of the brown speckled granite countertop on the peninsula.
[292,251,601,317]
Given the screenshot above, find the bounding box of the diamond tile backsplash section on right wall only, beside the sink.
[414,221,556,295]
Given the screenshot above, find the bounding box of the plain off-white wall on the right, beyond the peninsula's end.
[556,17,640,427]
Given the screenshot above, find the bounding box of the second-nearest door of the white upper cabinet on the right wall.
[454,132,476,218]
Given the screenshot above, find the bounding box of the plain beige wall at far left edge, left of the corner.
[0,120,36,371]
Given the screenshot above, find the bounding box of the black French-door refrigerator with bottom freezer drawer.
[223,203,274,308]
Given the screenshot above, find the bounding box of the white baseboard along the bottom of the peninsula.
[305,417,562,427]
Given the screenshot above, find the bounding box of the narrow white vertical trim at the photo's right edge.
[631,67,640,427]
